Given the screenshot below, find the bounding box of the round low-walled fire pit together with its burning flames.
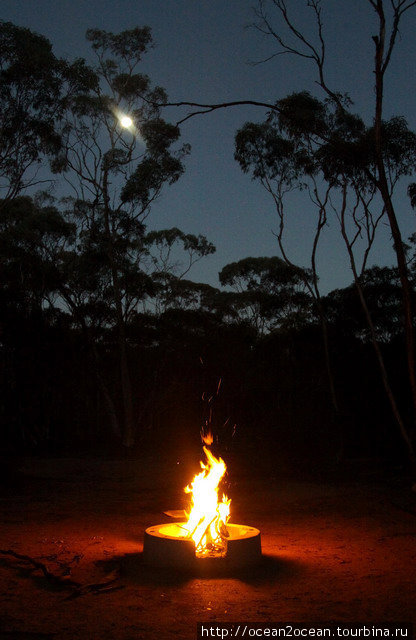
[143,434,261,570]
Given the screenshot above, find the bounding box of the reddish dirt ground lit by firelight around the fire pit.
[0,458,416,640]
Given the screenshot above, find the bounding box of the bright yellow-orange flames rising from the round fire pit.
[185,435,231,558]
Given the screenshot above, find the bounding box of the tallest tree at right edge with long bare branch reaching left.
[158,0,416,466]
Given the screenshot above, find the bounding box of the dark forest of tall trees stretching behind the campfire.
[0,8,416,480]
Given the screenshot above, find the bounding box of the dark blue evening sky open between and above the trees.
[0,0,416,291]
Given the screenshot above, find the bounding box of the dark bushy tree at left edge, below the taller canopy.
[0,196,74,446]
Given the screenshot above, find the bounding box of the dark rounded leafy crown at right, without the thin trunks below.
[235,92,416,190]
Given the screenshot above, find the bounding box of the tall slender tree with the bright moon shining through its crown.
[53,27,189,446]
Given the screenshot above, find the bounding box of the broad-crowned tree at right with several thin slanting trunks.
[236,92,416,460]
